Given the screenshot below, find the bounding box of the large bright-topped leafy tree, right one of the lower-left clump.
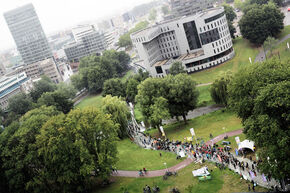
[29,108,117,193]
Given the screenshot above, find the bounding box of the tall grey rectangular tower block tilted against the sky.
[4,4,52,64]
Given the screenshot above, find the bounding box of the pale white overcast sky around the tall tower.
[0,0,151,51]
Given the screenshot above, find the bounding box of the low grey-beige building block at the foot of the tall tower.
[7,58,62,83]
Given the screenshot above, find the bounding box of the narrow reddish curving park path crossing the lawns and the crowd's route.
[113,129,243,178]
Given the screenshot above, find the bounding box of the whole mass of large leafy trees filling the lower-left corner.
[0,106,117,193]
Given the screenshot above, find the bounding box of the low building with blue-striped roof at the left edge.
[0,72,33,111]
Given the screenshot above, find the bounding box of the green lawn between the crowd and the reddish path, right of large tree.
[116,139,181,171]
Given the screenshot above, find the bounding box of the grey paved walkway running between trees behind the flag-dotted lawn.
[162,105,224,124]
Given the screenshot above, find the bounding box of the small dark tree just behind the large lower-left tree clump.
[37,91,73,113]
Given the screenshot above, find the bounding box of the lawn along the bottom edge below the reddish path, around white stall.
[94,163,266,193]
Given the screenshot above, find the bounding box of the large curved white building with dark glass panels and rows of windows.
[131,8,234,77]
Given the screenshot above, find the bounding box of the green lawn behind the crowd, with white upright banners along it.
[149,110,242,142]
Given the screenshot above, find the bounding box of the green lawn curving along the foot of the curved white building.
[191,38,259,84]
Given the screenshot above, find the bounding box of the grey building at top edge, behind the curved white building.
[170,0,213,17]
